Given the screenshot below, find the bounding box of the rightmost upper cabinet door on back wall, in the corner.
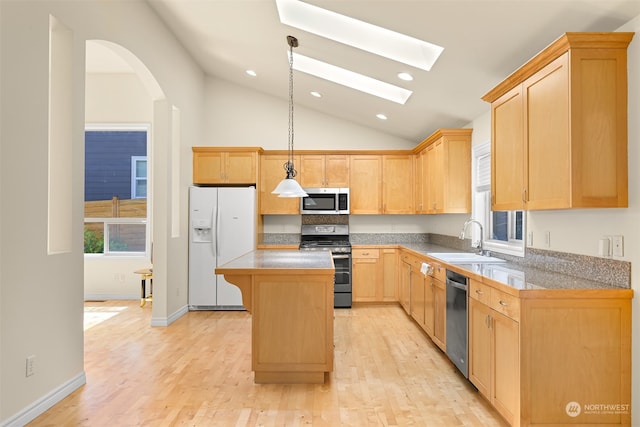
[382,154,415,214]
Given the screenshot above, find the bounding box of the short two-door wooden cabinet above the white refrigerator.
[192,147,262,185]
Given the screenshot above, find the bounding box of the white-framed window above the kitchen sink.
[473,142,525,256]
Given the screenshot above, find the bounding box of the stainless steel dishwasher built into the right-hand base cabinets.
[446,270,469,378]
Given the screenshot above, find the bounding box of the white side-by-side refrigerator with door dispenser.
[189,187,256,310]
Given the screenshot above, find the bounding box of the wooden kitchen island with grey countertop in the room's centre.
[215,250,335,384]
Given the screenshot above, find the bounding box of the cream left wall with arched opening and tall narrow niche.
[0,0,204,425]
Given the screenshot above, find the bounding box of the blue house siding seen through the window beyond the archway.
[84,130,147,201]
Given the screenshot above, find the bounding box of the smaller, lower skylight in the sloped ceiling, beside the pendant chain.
[287,52,413,104]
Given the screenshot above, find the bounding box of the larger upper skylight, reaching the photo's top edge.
[276,0,444,71]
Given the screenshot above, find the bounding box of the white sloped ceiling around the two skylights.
[121,0,640,142]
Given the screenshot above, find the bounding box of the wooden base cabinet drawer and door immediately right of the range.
[352,249,382,302]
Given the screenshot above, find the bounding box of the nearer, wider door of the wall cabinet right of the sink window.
[523,53,568,209]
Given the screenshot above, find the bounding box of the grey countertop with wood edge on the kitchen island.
[215,250,334,274]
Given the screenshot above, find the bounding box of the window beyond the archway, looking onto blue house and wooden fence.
[84,126,150,256]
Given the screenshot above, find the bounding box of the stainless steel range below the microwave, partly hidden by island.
[300,224,351,308]
